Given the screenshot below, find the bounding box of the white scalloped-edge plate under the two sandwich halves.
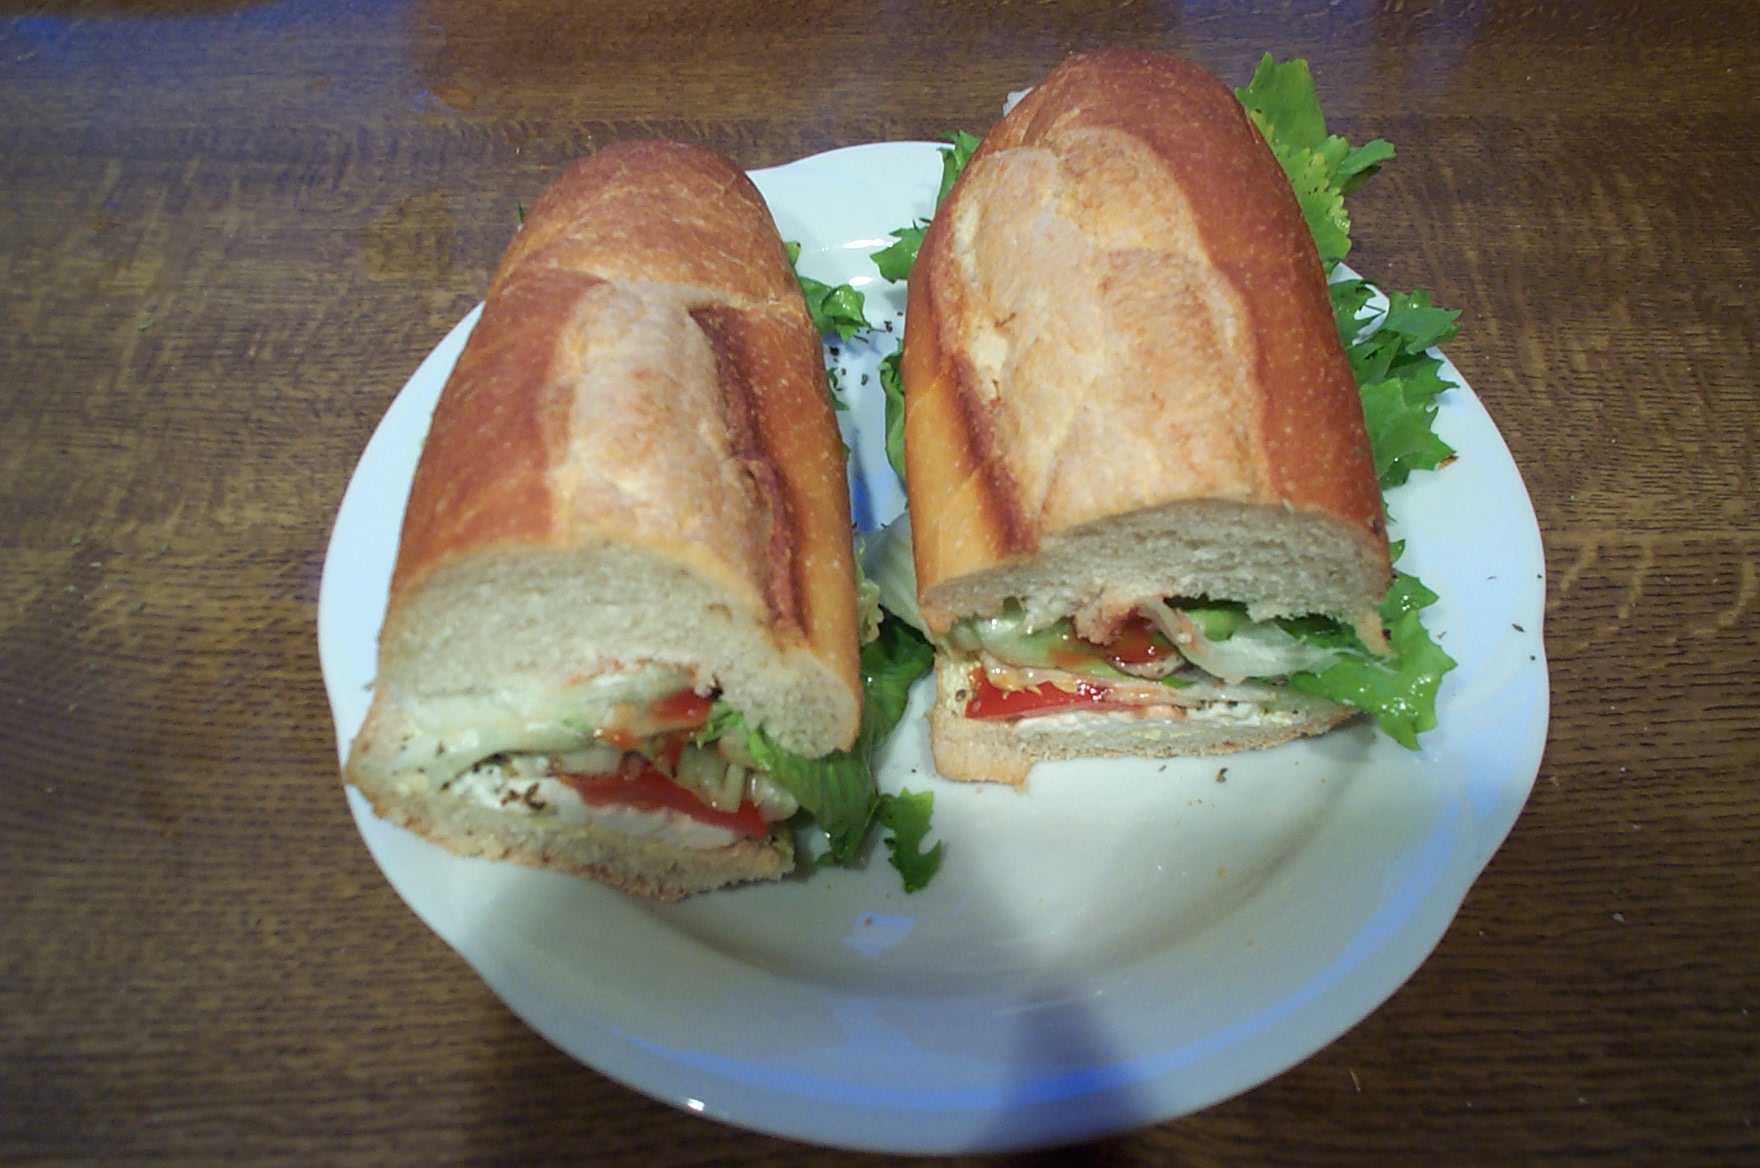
[319,142,1547,1152]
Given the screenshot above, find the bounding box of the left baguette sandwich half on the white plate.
[345,141,862,899]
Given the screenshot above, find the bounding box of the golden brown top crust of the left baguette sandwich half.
[387,142,859,717]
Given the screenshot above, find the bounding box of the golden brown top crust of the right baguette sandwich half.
[903,51,1385,624]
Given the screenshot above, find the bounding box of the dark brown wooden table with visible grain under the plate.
[0,0,1760,1168]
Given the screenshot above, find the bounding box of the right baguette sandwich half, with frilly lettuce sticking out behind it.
[901,51,1392,785]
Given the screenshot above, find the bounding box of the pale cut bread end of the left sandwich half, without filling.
[347,542,844,901]
